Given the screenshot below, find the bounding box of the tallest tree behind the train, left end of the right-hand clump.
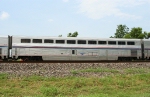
[110,24,129,38]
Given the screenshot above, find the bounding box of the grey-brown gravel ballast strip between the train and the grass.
[0,62,150,77]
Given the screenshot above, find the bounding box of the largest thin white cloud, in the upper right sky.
[78,0,150,19]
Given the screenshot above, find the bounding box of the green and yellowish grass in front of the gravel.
[0,68,150,97]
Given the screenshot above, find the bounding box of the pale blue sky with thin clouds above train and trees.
[0,0,150,38]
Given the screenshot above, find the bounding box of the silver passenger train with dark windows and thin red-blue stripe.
[0,36,150,61]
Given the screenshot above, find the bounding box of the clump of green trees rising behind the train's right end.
[110,24,150,39]
